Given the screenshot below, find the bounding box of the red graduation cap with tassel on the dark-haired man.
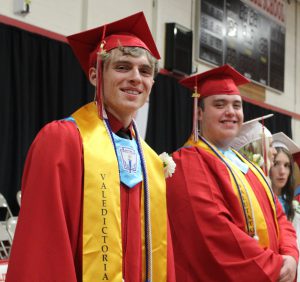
[179,65,250,142]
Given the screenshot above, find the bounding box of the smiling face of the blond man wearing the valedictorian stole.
[90,49,154,127]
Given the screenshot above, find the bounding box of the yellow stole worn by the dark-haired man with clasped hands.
[185,138,279,248]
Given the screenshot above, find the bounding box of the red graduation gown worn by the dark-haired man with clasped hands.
[167,147,298,282]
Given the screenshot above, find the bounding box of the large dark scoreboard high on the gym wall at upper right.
[195,0,285,91]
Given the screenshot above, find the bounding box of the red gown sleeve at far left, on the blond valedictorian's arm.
[6,121,83,282]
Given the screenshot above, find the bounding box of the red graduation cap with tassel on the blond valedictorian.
[67,12,160,119]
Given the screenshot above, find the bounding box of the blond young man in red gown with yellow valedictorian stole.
[6,13,175,282]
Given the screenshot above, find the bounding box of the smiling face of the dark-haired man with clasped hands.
[199,95,244,149]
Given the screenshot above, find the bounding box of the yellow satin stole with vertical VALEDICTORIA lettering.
[72,102,167,282]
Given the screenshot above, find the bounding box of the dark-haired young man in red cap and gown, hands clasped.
[167,65,298,282]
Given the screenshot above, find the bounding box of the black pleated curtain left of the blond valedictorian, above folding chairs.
[0,24,93,214]
